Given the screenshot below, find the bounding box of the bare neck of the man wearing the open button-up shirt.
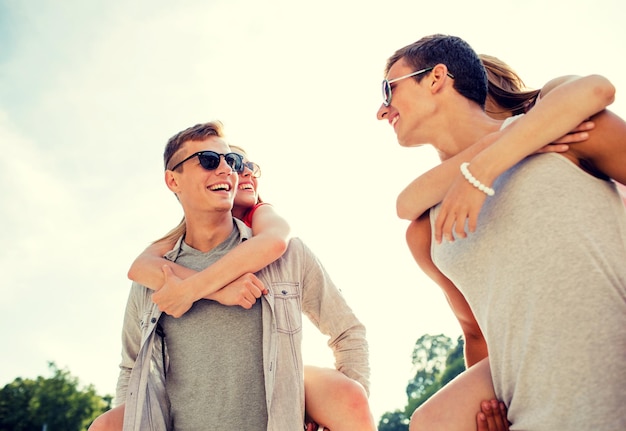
[185,211,234,252]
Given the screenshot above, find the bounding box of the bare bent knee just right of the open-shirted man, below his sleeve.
[304,365,376,431]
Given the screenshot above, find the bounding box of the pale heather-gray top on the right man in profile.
[431,153,626,431]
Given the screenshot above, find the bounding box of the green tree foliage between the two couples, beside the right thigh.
[378,334,465,431]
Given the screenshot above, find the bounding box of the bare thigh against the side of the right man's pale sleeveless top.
[409,358,496,431]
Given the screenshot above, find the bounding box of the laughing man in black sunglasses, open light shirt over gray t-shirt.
[111,123,369,431]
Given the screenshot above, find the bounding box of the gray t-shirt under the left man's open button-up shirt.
[160,227,267,431]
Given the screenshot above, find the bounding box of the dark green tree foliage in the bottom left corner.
[0,362,112,431]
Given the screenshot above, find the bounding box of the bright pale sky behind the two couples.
[0,0,626,426]
